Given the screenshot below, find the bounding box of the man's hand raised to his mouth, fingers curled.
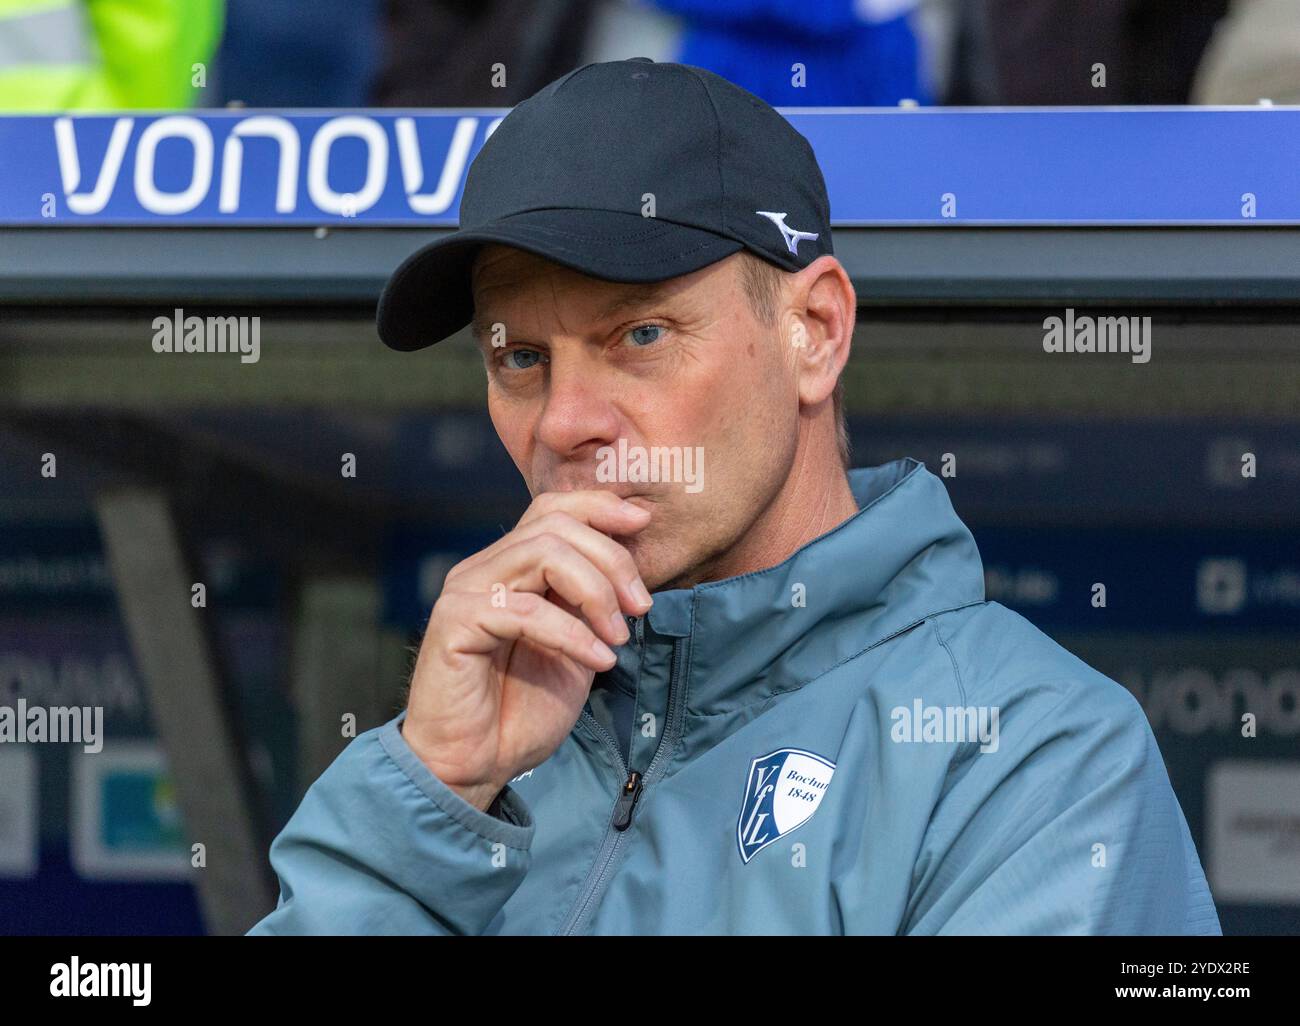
[402,490,651,809]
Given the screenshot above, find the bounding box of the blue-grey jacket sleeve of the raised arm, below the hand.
[248,713,534,936]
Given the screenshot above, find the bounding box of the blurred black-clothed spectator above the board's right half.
[944,0,1227,107]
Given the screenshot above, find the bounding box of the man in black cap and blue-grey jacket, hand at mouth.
[252,60,1218,934]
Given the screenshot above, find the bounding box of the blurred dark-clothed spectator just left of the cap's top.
[374,0,594,107]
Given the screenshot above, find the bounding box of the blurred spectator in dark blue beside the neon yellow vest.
[218,0,379,107]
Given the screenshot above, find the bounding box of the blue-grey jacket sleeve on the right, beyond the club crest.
[901,675,1221,935]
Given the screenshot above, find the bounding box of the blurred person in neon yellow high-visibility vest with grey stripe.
[0,0,222,112]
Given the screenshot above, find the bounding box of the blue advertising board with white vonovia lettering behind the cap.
[0,107,1300,228]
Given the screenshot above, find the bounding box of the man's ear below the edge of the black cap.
[785,255,858,406]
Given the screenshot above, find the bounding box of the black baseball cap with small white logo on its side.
[378,57,833,351]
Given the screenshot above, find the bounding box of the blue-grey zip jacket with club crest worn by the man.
[251,459,1219,934]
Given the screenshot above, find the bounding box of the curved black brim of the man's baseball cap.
[377,209,744,352]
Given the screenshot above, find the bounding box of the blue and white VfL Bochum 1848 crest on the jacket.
[736,748,835,862]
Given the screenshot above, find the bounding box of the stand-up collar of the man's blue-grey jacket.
[610,459,984,715]
